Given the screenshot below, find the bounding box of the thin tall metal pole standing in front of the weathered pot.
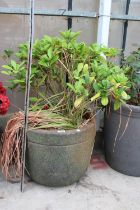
[20,0,34,192]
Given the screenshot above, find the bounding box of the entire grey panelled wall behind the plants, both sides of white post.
[0,0,140,60]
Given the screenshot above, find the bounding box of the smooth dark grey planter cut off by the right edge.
[104,105,140,176]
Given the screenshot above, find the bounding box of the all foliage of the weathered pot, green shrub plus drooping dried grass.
[2,30,131,179]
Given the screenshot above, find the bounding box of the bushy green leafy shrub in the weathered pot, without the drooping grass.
[2,30,131,127]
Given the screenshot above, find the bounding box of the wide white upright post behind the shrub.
[97,0,112,46]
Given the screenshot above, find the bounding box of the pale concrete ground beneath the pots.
[0,151,140,210]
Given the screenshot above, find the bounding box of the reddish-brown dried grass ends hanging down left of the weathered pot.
[1,112,35,180]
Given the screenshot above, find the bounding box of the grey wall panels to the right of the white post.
[109,0,140,55]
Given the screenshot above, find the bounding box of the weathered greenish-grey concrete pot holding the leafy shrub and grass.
[26,120,96,187]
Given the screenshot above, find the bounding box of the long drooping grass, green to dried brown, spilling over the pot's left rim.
[1,111,74,181]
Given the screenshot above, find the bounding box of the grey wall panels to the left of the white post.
[0,0,98,58]
